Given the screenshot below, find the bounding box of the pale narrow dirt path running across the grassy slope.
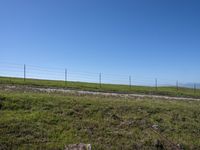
[0,85,200,101]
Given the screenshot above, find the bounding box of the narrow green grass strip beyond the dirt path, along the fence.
[0,77,200,98]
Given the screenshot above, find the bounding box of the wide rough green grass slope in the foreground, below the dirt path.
[0,88,200,150]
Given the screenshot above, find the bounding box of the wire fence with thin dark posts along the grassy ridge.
[0,63,200,90]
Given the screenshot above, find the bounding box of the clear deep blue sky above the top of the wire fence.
[0,0,200,82]
